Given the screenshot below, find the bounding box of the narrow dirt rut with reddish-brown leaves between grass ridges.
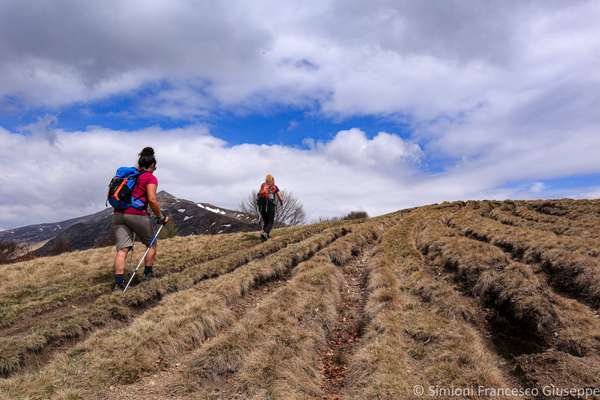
[321,244,376,400]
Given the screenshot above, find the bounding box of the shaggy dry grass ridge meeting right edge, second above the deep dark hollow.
[452,210,600,308]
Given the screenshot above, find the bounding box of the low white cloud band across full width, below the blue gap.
[0,118,600,227]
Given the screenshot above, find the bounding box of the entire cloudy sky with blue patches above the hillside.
[0,0,600,228]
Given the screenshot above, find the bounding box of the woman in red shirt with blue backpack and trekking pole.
[108,147,169,291]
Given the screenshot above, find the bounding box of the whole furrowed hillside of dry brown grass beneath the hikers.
[0,200,600,399]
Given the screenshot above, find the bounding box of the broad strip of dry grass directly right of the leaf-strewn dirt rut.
[346,211,515,400]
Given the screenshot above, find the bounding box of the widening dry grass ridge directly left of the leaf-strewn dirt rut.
[182,222,385,399]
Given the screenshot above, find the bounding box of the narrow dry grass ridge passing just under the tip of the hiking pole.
[0,226,330,376]
